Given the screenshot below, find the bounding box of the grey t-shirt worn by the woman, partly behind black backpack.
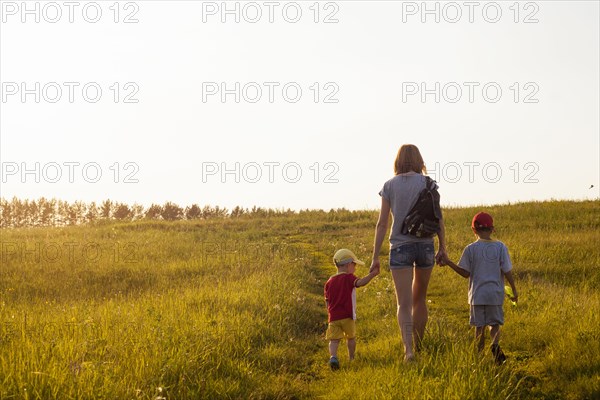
[379,172,438,249]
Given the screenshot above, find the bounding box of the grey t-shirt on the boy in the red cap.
[458,239,512,306]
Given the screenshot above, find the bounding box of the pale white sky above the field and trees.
[0,1,600,210]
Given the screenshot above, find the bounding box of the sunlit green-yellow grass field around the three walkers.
[0,201,600,400]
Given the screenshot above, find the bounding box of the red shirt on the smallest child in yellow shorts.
[325,273,358,322]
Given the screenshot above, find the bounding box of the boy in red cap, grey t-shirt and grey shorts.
[443,212,518,365]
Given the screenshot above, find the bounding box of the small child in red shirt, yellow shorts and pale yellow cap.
[325,249,379,371]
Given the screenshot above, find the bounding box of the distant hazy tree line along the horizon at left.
[0,197,351,228]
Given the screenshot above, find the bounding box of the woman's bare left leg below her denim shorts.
[392,268,415,361]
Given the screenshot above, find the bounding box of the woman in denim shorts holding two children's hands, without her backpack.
[371,144,446,361]
